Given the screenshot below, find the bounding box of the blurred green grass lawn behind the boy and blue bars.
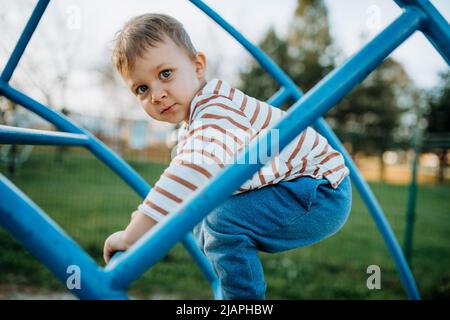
[0,147,450,299]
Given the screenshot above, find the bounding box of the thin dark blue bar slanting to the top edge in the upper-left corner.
[0,0,50,82]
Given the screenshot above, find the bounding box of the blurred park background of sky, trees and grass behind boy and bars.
[0,0,450,299]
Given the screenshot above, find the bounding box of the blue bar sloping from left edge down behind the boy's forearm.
[0,80,218,296]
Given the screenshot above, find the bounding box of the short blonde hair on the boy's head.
[112,13,197,75]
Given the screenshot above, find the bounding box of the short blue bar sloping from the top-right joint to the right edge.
[395,0,450,66]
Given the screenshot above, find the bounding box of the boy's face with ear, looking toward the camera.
[124,37,206,124]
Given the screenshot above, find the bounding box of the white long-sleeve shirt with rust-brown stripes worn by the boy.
[139,79,349,221]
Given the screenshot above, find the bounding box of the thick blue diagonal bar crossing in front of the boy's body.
[103,10,423,298]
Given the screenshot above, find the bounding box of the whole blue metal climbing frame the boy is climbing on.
[0,0,450,299]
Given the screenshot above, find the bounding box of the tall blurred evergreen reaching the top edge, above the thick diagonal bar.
[240,0,336,106]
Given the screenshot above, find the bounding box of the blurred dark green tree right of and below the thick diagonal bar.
[327,58,420,179]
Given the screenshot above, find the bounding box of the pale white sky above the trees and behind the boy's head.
[0,0,450,118]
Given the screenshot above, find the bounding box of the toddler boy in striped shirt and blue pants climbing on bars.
[104,14,351,299]
